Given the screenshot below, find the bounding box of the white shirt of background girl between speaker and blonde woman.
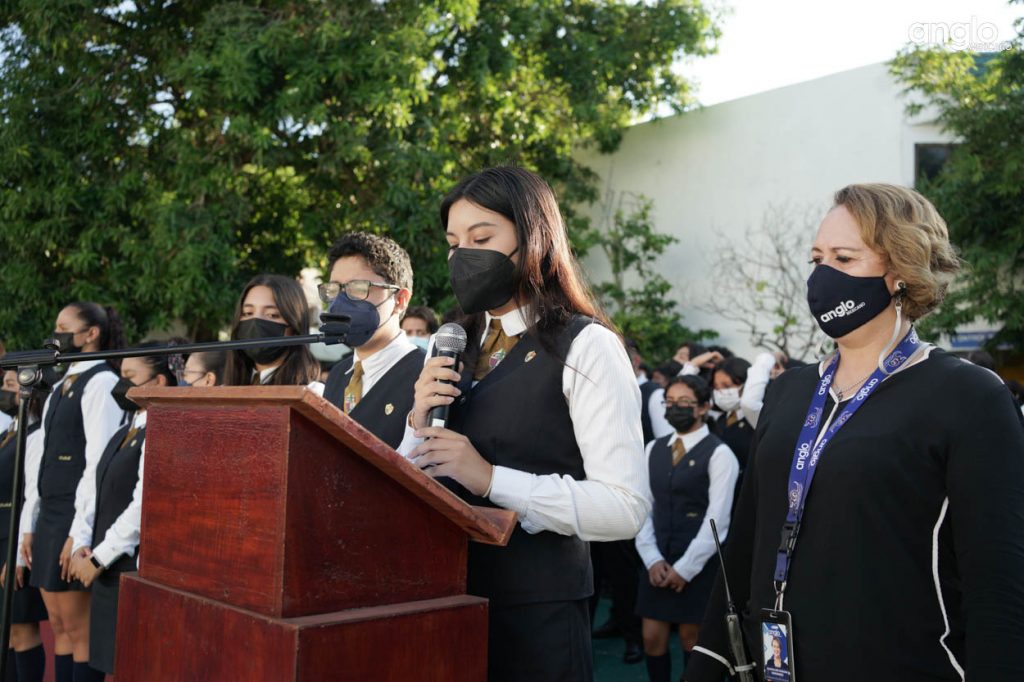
[636,424,739,583]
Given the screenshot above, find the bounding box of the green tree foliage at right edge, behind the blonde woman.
[892,9,1024,349]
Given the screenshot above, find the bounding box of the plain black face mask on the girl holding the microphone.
[449,248,519,315]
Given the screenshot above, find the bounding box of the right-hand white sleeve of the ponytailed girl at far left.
[69,372,125,550]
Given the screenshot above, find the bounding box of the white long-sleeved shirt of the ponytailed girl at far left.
[19,360,125,548]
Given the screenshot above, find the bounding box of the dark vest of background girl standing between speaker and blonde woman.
[647,433,722,564]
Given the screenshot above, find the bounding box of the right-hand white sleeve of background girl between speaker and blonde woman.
[672,444,739,583]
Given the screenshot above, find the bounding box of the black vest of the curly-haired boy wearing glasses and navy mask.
[324,348,426,447]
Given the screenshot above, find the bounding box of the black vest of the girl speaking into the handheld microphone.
[442,317,594,604]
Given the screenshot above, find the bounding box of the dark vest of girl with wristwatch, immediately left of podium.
[92,424,145,573]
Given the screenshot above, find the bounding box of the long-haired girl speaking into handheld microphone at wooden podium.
[399,168,650,680]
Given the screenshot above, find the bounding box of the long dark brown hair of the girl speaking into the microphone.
[440,166,614,360]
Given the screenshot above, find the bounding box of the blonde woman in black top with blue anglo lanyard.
[686,184,1024,682]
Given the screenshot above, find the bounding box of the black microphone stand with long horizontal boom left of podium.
[0,323,349,680]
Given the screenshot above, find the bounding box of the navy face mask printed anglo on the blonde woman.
[807,265,892,339]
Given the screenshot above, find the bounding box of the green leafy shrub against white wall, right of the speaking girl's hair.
[587,191,715,364]
